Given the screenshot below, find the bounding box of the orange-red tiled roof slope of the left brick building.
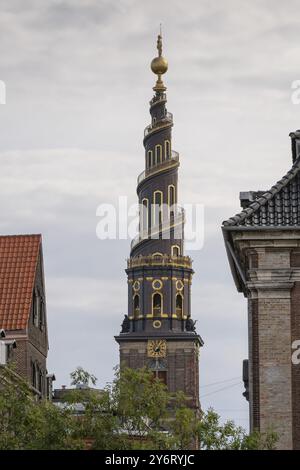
[0,235,42,330]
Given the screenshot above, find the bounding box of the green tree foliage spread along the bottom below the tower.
[0,368,277,450]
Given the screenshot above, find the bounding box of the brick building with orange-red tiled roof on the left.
[0,235,54,398]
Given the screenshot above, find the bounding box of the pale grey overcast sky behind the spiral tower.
[0,0,300,426]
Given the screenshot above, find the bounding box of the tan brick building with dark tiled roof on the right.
[222,131,300,450]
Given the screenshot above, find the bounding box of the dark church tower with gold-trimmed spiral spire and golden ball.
[116,35,203,409]
